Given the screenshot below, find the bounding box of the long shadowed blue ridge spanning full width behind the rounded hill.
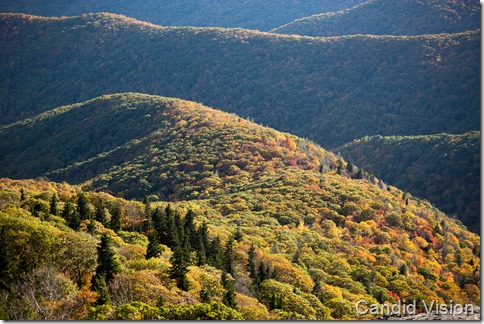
[0,14,480,147]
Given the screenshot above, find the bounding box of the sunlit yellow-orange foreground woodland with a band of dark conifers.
[0,144,480,319]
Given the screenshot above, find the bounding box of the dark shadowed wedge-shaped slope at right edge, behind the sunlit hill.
[336,132,481,232]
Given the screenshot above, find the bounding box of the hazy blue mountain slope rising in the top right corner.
[272,0,481,36]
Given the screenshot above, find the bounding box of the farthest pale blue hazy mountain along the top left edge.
[0,0,364,30]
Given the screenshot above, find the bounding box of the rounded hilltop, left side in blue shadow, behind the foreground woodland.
[0,93,336,199]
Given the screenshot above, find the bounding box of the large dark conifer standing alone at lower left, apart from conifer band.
[91,234,120,305]
